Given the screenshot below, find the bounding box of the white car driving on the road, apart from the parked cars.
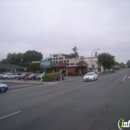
[83,72,98,82]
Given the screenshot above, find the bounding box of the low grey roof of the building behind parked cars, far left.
[0,64,24,69]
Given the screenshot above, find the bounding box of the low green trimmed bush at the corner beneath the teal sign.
[42,73,60,82]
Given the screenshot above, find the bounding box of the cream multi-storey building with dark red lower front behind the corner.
[47,53,87,75]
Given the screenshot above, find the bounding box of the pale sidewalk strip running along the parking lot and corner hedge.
[0,76,80,85]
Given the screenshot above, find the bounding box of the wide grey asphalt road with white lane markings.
[0,70,130,130]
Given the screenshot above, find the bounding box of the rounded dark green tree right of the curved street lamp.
[98,53,115,72]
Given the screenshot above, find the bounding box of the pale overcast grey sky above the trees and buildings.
[0,0,130,63]
